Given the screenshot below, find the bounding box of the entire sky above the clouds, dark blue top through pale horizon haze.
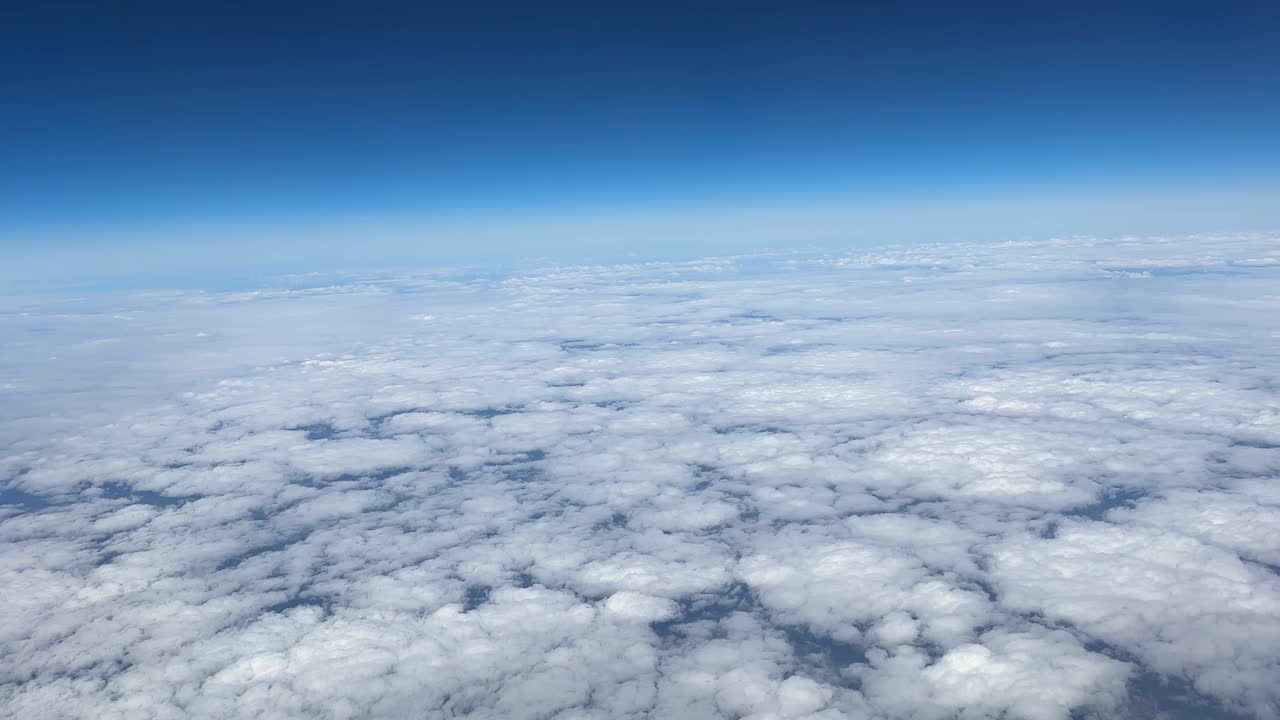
[0,1,1280,288]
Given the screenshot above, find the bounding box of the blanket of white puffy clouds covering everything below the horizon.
[0,236,1280,720]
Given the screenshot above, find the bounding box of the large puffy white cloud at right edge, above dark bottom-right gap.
[993,521,1280,715]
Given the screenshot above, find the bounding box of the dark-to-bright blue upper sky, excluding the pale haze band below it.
[0,1,1280,269]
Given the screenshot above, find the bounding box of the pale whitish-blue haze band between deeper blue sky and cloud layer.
[10,186,1280,291]
